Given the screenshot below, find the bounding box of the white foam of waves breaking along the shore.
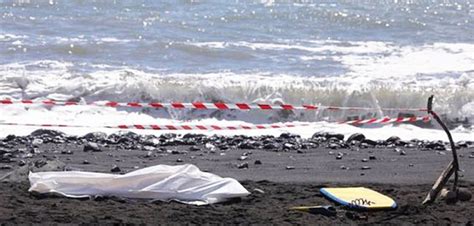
[0,37,474,140]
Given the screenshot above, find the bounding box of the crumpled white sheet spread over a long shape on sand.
[28,164,250,205]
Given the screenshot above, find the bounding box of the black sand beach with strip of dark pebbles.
[0,130,474,225]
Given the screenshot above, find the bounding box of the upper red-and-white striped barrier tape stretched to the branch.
[0,99,426,112]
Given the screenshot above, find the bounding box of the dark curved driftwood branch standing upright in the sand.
[422,96,459,204]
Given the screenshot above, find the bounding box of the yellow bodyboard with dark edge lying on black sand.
[320,187,397,209]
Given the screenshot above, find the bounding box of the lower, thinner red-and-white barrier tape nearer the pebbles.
[0,116,431,130]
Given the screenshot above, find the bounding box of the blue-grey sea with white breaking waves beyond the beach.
[0,0,474,139]
